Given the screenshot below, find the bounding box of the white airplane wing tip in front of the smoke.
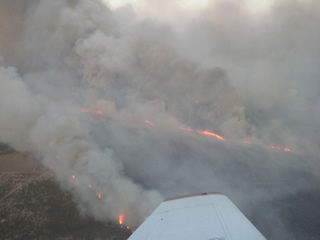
[128,193,266,240]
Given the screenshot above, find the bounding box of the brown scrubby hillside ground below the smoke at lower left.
[0,143,131,240]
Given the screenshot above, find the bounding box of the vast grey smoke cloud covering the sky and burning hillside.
[0,0,320,239]
